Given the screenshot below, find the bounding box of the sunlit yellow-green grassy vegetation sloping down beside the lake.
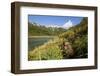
[28,38,64,60]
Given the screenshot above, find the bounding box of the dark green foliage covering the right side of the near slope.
[59,18,88,58]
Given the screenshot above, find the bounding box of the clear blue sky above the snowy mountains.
[28,15,83,26]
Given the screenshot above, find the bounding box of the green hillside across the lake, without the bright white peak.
[28,23,66,36]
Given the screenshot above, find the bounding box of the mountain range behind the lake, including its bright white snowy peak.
[28,20,73,36]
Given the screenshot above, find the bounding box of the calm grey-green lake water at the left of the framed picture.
[28,36,54,51]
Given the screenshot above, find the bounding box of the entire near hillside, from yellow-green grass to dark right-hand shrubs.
[28,18,88,60]
